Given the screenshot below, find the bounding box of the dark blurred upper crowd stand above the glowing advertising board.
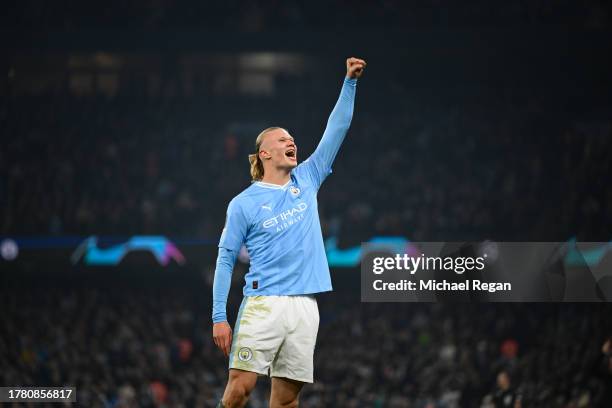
[0,77,612,245]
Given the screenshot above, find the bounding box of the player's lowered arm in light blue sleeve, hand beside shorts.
[212,200,247,357]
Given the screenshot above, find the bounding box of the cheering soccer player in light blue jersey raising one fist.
[212,58,366,408]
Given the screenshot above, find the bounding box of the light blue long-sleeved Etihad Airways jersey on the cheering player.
[213,78,357,322]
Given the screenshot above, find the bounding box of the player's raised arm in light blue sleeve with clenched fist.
[304,57,366,186]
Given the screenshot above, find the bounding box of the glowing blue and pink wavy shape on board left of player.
[70,235,185,266]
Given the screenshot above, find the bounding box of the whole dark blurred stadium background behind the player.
[0,0,612,407]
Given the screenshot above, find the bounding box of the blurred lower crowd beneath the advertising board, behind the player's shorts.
[0,288,612,408]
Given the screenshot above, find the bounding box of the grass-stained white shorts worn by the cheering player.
[229,295,319,383]
